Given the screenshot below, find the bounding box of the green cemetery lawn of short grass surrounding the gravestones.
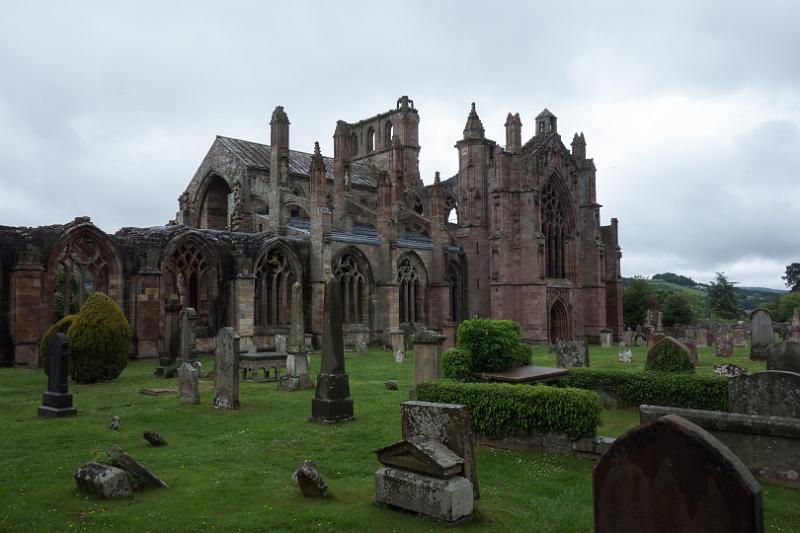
[0,347,800,533]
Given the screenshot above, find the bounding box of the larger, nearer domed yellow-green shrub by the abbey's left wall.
[67,292,131,383]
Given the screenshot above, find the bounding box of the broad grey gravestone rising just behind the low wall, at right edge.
[728,370,800,418]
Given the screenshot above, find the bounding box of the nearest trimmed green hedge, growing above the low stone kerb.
[417,379,601,438]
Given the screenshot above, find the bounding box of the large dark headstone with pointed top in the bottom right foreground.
[592,415,764,533]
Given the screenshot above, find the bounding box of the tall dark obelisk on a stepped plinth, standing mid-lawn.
[310,278,354,424]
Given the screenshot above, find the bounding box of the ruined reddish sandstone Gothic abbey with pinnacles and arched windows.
[0,96,622,365]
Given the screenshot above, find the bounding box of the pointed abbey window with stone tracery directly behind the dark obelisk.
[255,246,295,327]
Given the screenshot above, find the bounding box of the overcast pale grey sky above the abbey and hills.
[0,0,800,288]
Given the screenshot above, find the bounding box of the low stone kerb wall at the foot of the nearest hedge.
[472,431,614,460]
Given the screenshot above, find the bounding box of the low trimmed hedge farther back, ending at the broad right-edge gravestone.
[562,368,728,411]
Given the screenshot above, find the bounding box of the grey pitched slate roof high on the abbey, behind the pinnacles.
[217,135,379,189]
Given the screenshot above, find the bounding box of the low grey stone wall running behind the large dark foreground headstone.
[639,405,800,487]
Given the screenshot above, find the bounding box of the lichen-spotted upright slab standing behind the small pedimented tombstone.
[400,401,481,500]
